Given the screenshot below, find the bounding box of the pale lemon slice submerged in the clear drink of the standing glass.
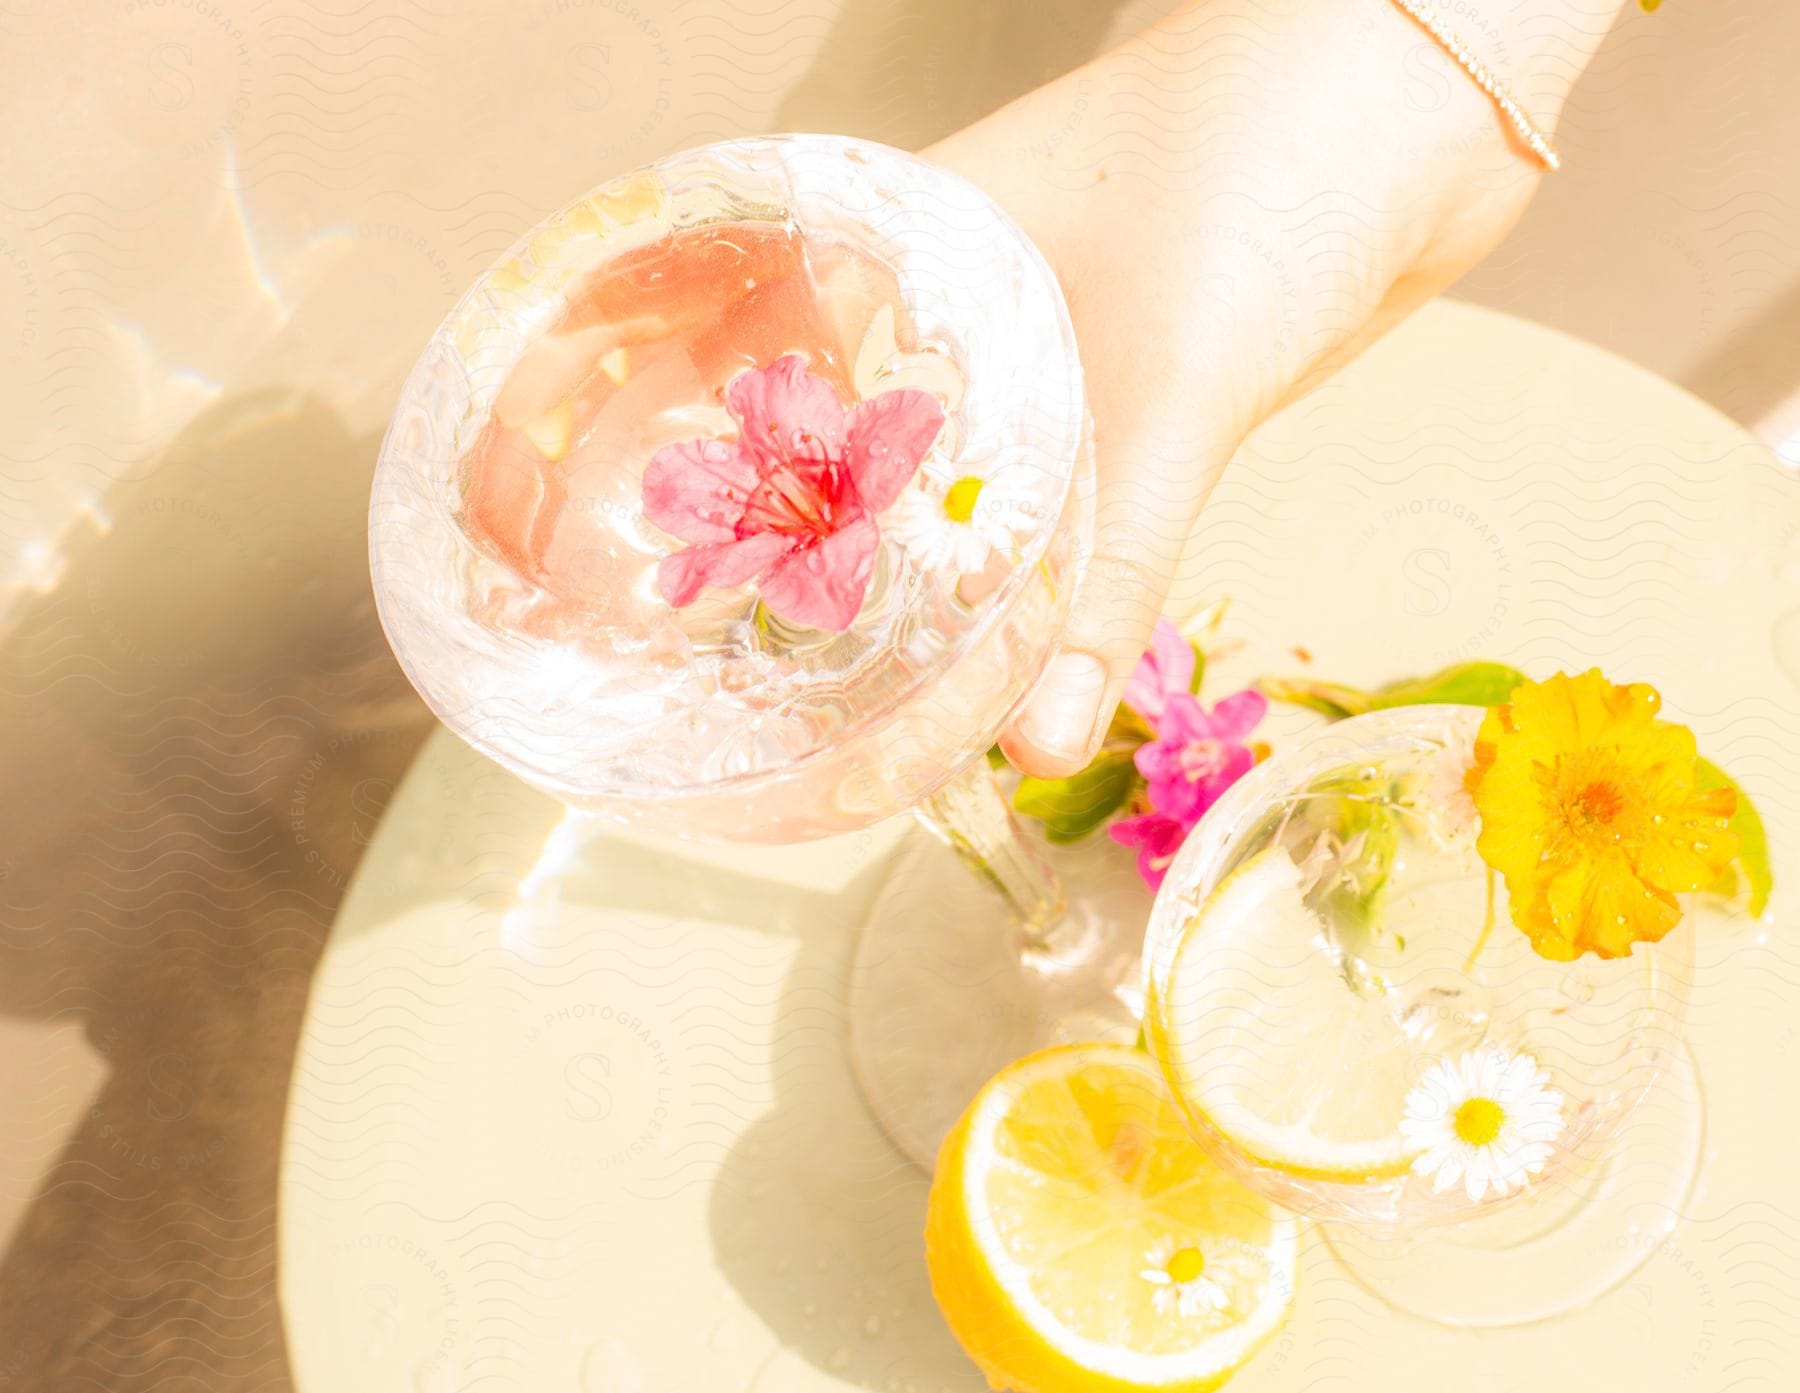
[1147,846,1420,1182]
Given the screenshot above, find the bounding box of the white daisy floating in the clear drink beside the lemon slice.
[1400,1046,1562,1200]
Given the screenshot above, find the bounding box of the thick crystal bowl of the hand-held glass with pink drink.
[371,137,1089,840]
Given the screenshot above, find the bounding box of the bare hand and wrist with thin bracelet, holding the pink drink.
[925,0,1618,777]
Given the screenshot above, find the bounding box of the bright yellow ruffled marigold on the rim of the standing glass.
[1467,668,1737,961]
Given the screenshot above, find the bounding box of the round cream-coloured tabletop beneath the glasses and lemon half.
[281,304,1800,1393]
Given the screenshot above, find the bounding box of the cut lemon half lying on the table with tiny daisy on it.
[925,1044,1296,1393]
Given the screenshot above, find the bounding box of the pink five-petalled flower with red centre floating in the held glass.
[644,355,943,632]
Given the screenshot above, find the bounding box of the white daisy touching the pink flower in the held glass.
[882,449,1046,576]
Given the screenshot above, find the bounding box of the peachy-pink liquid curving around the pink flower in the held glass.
[461,221,905,637]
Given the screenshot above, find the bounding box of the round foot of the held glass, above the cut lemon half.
[850,828,1150,1172]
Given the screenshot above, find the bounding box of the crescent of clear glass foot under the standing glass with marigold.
[1325,1046,1705,1326]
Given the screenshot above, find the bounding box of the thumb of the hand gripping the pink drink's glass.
[1001,436,1219,777]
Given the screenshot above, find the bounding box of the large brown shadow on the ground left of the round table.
[0,392,430,1393]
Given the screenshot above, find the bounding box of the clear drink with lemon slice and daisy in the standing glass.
[1147,707,1692,1226]
